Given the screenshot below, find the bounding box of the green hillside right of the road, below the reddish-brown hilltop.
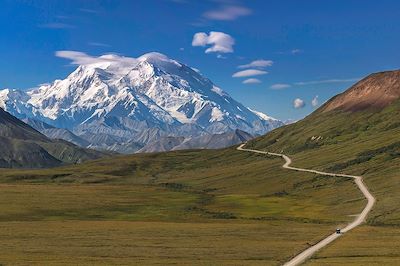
[247,101,400,225]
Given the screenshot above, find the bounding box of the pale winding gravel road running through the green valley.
[237,143,375,266]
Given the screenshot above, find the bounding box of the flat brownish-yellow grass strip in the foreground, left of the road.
[0,220,332,265]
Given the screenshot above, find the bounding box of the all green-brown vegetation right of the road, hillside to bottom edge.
[248,101,400,265]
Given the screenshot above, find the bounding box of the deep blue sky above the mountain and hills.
[0,0,400,120]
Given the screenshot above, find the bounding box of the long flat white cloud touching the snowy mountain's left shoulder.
[56,51,137,65]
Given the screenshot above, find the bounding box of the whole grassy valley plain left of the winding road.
[0,148,365,265]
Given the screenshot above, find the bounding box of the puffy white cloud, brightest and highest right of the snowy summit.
[192,31,235,53]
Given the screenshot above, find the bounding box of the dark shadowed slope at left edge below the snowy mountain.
[0,108,102,168]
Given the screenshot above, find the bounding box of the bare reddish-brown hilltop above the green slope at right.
[321,70,400,112]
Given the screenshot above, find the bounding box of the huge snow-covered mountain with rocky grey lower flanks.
[0,53,283,152]
